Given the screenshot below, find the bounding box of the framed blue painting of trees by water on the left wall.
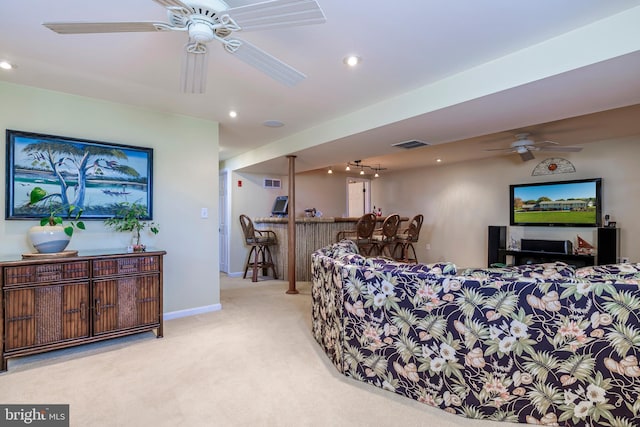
[5,129,153,220]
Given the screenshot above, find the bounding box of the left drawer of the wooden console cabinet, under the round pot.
[4,261,89,286]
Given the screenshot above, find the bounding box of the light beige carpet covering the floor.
[0,275,514,427]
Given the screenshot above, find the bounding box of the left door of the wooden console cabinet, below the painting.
[5,283,89,351]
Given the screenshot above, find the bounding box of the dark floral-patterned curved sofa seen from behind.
[312,240,640,427]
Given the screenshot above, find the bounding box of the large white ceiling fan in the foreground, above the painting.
[43,0,326,93]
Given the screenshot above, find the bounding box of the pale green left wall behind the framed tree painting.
[0,82,220,312]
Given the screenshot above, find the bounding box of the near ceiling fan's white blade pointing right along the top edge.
[224,0,326,31]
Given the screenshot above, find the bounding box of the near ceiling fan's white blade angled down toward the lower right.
[224,39,307,86]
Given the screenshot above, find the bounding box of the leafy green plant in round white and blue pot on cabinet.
[28,187,85,253]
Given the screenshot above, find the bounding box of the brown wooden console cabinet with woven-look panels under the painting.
[0,251,166,371]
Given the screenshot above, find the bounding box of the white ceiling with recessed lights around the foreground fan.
[0,0,640,173]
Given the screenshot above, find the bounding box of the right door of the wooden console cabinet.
[93,274,160,335]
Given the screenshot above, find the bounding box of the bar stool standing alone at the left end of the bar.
[240,215,278,282]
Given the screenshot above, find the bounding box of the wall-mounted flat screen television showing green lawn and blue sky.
[509,178,602,227]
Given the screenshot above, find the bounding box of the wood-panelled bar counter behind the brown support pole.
[253,216,408,282]
